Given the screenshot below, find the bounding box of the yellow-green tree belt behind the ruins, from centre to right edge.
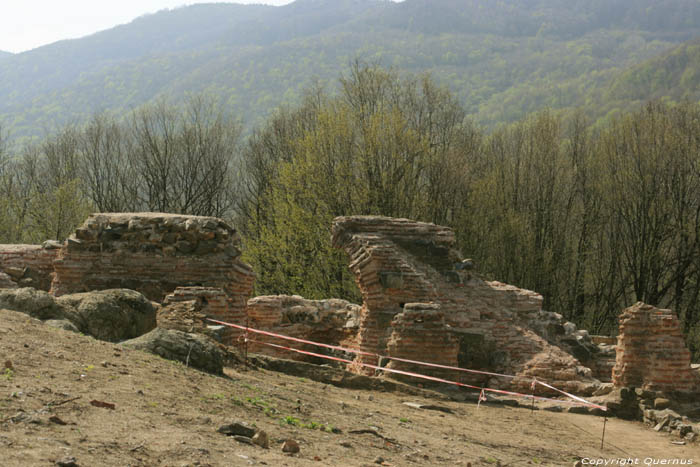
[238,64,700,360]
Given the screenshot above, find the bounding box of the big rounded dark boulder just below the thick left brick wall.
[56,289,156,342]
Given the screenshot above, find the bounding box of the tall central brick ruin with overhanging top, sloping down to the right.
[333,216,596,394]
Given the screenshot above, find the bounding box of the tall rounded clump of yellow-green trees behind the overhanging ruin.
[239,63,475,300]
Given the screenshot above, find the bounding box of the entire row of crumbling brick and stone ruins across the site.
[0,213,700,402]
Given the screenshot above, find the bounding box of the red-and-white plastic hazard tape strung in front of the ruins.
[208,318,607,411]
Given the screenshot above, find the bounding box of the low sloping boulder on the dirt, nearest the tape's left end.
[122,328,225,375]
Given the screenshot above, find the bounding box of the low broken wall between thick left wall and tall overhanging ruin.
[248,295,361,362]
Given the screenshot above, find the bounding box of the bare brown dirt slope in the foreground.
[0,311,700,466]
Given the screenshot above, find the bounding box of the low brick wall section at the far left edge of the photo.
[0,242,58,291]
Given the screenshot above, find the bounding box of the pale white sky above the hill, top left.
[0,0,292,52]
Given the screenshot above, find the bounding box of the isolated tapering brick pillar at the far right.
[612,302,700,393]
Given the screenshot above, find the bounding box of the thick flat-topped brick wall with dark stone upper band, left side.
[51,213,254,306]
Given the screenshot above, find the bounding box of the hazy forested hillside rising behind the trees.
[0,0,700,143]
